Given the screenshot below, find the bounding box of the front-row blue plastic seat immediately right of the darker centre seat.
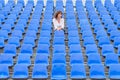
[70,64,86,79]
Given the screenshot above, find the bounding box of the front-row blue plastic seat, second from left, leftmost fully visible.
[12,64,28,79]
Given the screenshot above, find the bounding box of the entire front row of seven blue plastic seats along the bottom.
[0,64,120,79]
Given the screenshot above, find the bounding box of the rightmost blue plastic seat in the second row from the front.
[105,54,119,66]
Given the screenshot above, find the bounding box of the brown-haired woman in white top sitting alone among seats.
[53,11,64,31]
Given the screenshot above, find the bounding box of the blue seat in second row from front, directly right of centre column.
[70,54,84,66]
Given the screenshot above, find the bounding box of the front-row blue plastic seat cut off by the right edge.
[109,64,120,79]
